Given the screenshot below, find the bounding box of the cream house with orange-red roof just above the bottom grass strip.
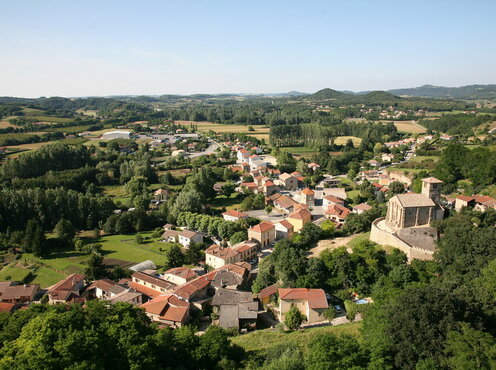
[278,288,329,323]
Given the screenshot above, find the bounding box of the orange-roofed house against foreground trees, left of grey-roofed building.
[140,294,190,328]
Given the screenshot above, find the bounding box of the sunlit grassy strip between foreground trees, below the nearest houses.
[231,322,361,352]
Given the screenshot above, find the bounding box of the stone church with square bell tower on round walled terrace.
[370,177,444,261]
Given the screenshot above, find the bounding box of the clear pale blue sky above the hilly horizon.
[0,0,496,97]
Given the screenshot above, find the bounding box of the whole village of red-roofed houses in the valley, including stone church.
[0,122,496,332]
